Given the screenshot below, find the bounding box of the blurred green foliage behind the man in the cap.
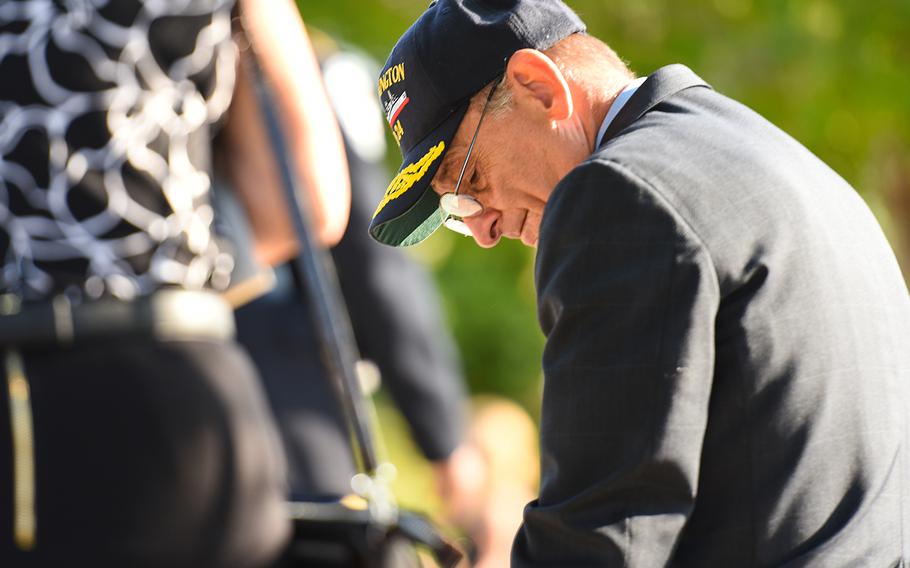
[299,0,910,413]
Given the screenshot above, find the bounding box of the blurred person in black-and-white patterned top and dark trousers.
[0,0,348,568]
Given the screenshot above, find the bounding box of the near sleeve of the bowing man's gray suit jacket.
[513,159,719,567]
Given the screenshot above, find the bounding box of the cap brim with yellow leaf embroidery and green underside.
[370,101,470,247]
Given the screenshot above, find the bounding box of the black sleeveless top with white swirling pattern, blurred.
[0,0,236,300]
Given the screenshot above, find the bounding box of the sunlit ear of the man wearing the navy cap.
[506,49,573,121]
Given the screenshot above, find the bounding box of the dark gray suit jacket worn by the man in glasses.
[513,65,910,568]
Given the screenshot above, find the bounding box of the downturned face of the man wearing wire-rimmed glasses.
[432,87,564,248]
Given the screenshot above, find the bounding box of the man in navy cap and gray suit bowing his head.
[370,0,910,567]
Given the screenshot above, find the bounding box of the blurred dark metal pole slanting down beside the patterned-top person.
[247,43,462,568]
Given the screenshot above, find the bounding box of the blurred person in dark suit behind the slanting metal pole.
[225,38,480,516]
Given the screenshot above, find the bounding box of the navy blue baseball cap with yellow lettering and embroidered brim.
[370,0,585,246]
